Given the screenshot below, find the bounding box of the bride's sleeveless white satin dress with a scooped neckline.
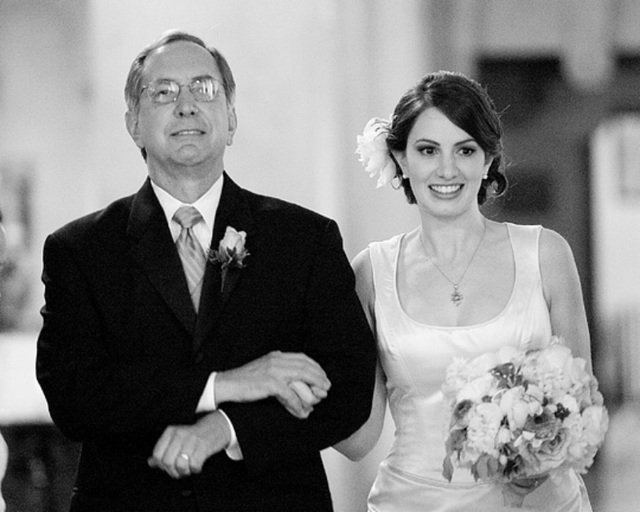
[368,224,592,512]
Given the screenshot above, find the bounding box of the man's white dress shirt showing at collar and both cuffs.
[151,177,242,460]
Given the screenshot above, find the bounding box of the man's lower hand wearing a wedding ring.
[148,411,231,478]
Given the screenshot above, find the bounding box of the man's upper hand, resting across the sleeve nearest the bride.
[215,351,331,419]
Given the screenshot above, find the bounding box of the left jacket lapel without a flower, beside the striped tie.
[127,179,196,334]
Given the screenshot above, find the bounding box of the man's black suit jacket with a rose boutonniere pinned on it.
[37,174,375,511]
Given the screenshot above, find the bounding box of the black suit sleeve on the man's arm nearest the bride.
[223,221,376,472]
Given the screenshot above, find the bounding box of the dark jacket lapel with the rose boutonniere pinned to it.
[195,173,255,348]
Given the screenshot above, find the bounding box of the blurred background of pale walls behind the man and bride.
[0,0,640,512]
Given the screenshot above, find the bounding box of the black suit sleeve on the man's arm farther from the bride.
[36,235,208,441]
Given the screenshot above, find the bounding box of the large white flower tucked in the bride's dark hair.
[356,117,396,188]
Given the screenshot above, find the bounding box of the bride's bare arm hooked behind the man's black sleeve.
[334,249,387,460]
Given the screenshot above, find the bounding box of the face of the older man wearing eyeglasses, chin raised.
[126,41,236,179]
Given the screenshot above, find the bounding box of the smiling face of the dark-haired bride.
[395,107,491,217]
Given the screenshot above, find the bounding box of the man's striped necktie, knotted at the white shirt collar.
[173,206,207,313]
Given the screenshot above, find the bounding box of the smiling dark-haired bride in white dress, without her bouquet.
[335,72,591,512]
